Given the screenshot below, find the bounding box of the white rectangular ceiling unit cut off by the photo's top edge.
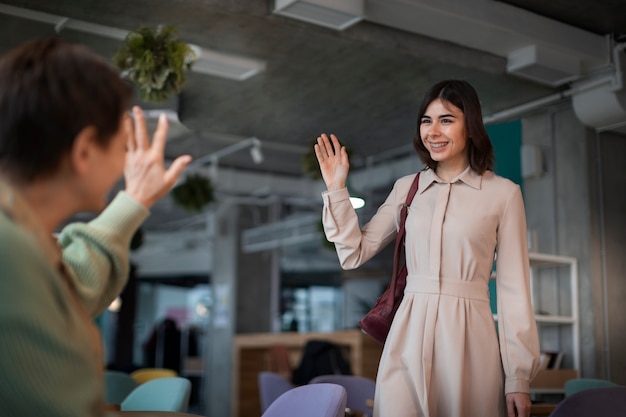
[274,0,363,30]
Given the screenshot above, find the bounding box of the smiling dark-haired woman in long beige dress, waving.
[315,80,539,417]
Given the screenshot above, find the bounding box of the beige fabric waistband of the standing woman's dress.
[404,274,489,301]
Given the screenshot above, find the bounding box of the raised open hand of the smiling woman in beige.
[315,133,350,191]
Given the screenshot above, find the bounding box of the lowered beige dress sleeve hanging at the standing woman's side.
[496,186,539,394]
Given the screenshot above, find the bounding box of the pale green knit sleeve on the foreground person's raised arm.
[59,191,149,317]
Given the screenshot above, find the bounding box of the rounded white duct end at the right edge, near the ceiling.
[572,45,626,131]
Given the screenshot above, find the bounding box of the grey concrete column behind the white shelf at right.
[522,107,595,375]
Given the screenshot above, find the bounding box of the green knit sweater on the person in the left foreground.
[0,181,148,417]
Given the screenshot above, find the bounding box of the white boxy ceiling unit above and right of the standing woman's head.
[506,45,581,87]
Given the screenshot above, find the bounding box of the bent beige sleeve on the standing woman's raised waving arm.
[322,176,413,269]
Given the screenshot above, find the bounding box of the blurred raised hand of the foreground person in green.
[124,106,191,208]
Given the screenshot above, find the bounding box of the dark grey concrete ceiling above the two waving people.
[0,0,626,231]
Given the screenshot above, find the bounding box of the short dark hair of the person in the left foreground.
[0,37,133,182]
